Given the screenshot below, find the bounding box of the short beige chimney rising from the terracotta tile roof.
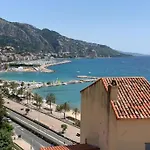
[108,80,118,101]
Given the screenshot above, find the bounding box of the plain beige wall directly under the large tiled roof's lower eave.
[117,119,150,150]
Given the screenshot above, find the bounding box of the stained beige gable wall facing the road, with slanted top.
[81,80,109,150]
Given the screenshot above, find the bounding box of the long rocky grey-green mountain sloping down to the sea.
[0,18,128,57]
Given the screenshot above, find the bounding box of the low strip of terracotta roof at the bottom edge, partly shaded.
[40,144,99,150]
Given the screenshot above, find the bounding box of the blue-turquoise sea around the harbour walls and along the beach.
[0,56,150,108]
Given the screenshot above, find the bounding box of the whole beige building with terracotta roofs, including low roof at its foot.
[41,77,150,150]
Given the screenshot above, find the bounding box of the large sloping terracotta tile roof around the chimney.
[101,77,150,119]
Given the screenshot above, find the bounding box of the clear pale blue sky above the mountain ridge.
[0,0,150,54]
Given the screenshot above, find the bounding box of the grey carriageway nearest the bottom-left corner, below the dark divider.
[11,122,52,150]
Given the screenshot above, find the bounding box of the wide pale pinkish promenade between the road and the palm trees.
[4,99,80,142]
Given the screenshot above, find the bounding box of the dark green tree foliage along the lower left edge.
[0,94,13,150]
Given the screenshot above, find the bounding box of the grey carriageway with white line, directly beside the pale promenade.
[7,109,73,145]
